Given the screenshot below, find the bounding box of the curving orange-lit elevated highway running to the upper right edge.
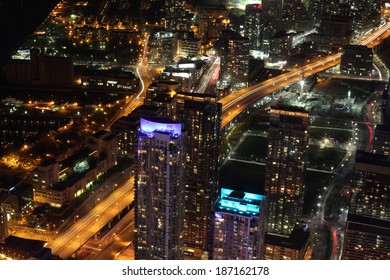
[219,23,390,128]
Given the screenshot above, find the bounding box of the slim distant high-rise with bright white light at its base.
[245,4,264,57]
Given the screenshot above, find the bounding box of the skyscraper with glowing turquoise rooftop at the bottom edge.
[213,188,267,260]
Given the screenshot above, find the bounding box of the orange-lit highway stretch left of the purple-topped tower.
[48,177,134,259]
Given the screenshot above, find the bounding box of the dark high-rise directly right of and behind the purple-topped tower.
[181,98,222,257]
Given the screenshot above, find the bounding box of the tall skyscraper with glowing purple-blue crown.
[134,118,185,260]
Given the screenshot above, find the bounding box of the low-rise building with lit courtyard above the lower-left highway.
[28,132,117,208]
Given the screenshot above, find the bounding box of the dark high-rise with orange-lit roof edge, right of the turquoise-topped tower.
[265,108,309,236]
